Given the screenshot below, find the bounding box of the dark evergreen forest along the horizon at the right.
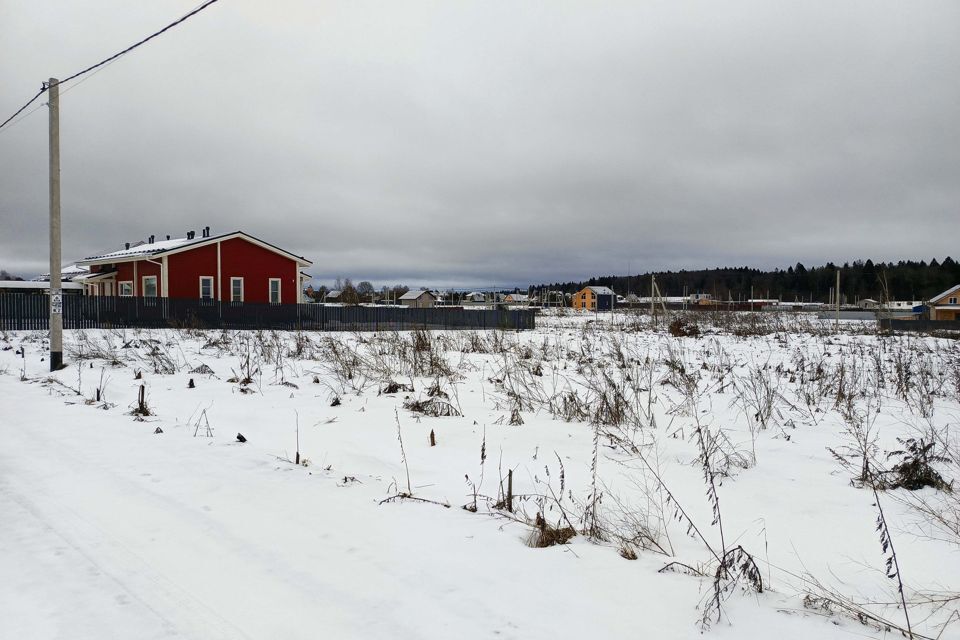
[537,257,960,302]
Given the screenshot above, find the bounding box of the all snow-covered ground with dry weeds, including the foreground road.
[0,314,960,640]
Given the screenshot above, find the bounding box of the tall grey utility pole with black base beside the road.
[47,78,63,371]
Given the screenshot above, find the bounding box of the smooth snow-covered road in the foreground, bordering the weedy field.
[0,360,892,640]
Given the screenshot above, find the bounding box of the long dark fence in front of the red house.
[0,293,535,331]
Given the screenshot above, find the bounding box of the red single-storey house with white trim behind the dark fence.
[77,227,312,304]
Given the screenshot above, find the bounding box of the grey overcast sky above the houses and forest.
[0,0,960,286]
